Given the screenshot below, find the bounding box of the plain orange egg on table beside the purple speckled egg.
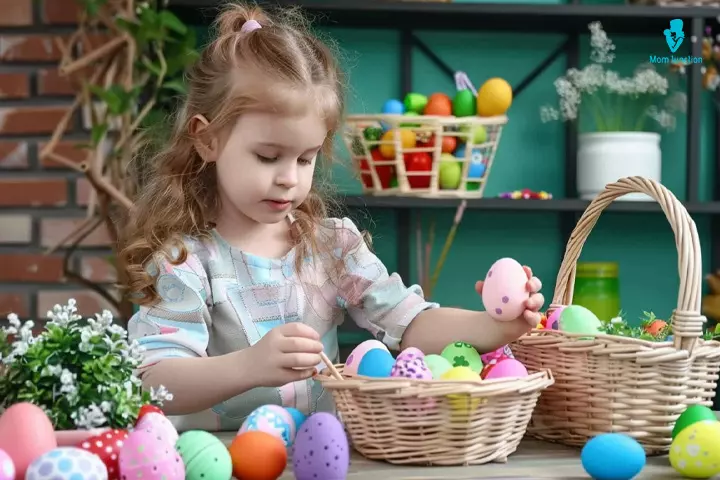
[228,430,287,480]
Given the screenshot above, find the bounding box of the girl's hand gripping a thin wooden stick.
[250,322,323,387]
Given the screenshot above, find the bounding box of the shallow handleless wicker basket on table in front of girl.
[317,366,553,465]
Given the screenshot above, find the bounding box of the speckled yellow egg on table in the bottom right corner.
[670,420,720,478]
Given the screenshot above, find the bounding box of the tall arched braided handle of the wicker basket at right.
[550,177,706,352]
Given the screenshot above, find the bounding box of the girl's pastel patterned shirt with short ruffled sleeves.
[128,218,438,431]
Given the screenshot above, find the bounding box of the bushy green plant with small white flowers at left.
[0,299,172,430]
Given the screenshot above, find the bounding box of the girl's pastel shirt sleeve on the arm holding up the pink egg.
[334,218,439,350]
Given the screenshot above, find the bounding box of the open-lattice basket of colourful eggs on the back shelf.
[344,115,507,198]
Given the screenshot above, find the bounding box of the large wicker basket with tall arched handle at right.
[512,177,720,455]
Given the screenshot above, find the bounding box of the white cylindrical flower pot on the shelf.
[577,132,662,201]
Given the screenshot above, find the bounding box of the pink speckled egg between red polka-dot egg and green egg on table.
[118,430,184,480]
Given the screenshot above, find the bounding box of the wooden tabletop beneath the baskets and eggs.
[212,433,682,480]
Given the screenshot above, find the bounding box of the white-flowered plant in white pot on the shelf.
[540,22,685,200]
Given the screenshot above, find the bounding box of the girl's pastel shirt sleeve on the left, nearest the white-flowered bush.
[128,254,210,375]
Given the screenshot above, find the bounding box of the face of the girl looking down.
[216,112,328,224]
